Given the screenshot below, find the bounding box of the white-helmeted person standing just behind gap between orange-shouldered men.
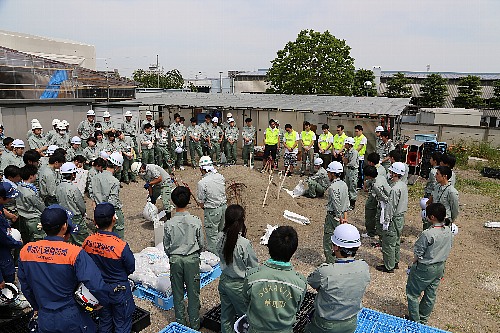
[56,162,89,246]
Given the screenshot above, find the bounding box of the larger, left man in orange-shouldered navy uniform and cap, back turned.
[18,205,110,333]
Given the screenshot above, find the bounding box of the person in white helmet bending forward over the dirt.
[131,162,174,218]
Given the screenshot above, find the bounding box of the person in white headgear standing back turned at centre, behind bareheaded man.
[197,156,227,253]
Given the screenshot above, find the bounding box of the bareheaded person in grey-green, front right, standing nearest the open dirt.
[406,203,453,325]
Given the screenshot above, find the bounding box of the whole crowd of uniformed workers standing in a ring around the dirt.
[0,110,459,332]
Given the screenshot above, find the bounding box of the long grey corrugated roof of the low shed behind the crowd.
[137,92,410,116]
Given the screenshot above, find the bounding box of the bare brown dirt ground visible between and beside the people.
[114,162,500,332]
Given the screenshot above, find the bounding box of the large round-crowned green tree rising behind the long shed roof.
[266,30,354,96]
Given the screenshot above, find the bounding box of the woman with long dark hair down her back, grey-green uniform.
[217,205,258,333]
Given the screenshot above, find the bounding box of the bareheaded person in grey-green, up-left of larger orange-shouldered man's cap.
[16,165,46,240]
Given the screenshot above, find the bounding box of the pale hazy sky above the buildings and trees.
[0,0,500,78]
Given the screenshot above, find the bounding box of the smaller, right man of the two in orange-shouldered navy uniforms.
[82,202,135,333]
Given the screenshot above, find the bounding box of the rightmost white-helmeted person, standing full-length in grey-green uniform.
[376,162,408,273]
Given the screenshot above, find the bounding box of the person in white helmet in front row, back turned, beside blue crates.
[305,223,370,333]
